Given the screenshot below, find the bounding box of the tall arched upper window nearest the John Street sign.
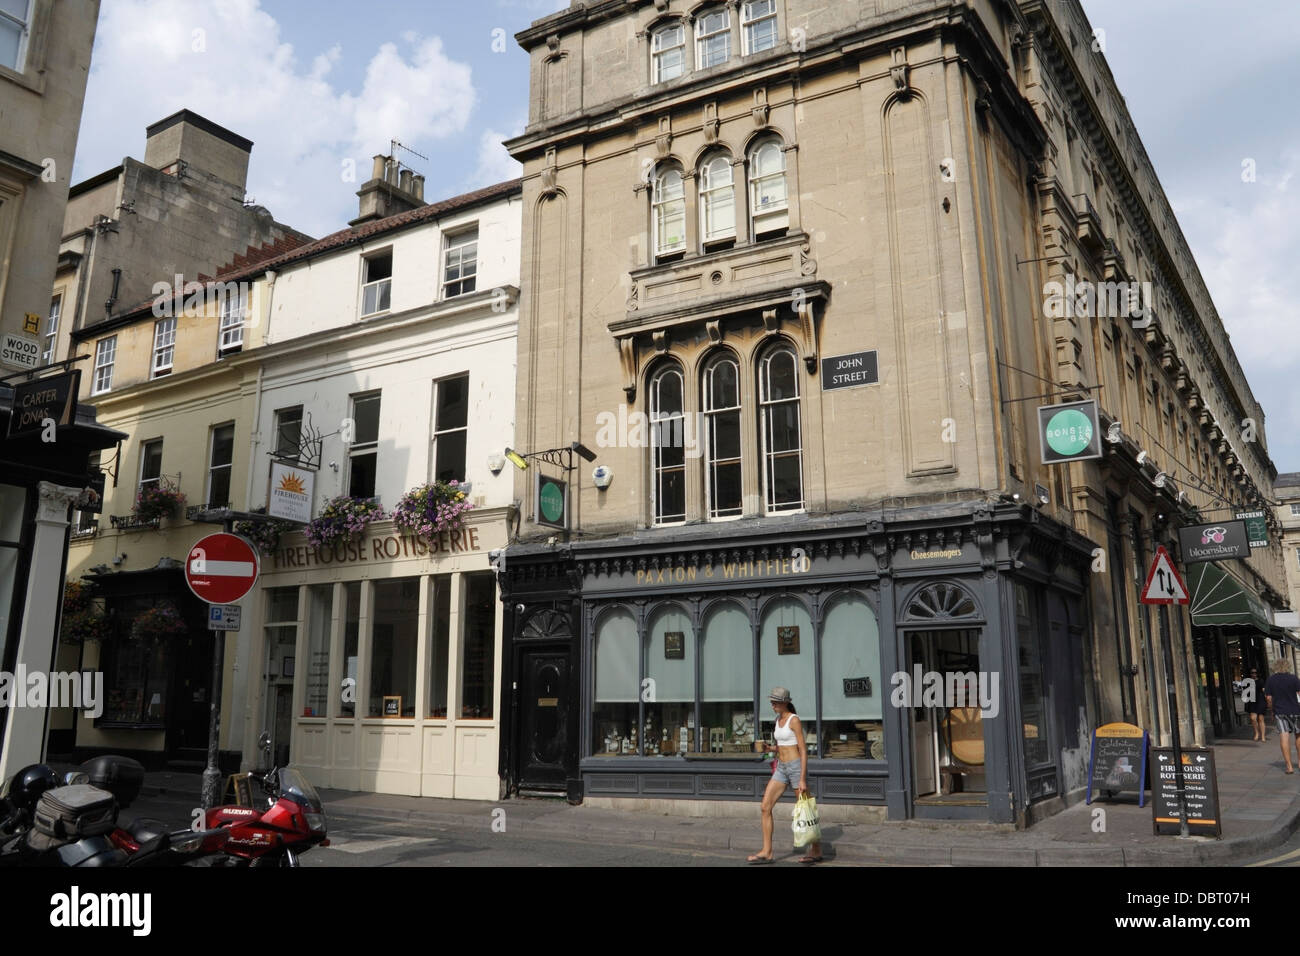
[758,346,803,514]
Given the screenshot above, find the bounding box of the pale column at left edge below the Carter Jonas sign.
[0,481,82,780]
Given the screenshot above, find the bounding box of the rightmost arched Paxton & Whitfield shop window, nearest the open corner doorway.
[821,594,889,760]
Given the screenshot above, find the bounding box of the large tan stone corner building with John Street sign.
[502,0,1282,823]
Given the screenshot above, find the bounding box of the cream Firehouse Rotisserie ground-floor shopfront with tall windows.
[248,509,506,800]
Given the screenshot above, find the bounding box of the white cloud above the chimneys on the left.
[74,0,477,235]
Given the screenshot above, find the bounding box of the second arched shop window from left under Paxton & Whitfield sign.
[641,605,696,757]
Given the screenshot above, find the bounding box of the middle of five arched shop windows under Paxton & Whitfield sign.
[692,602,754,753]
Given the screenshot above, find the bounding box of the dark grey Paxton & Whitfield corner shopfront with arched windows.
[502,502,1092,825]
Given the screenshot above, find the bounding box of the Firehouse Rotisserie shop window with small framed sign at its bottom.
[369,578,420,717]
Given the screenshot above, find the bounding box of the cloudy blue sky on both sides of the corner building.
[73,0,1300,471]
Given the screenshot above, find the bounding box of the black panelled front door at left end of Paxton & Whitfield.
[516,648,575,791]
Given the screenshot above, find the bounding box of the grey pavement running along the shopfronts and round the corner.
[78,722,1300,866]
